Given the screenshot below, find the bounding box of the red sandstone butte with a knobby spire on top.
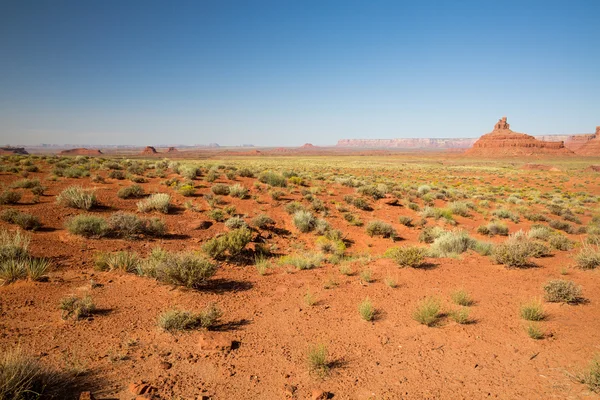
[466,117,575,157]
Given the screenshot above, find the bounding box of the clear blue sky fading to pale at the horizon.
[0,0,600,146]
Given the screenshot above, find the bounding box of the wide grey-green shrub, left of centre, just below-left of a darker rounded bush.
[147,249,217,289]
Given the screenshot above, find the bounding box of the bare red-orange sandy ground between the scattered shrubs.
[0,158,600,400]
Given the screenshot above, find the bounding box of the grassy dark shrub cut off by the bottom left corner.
[0,346,66,400]
